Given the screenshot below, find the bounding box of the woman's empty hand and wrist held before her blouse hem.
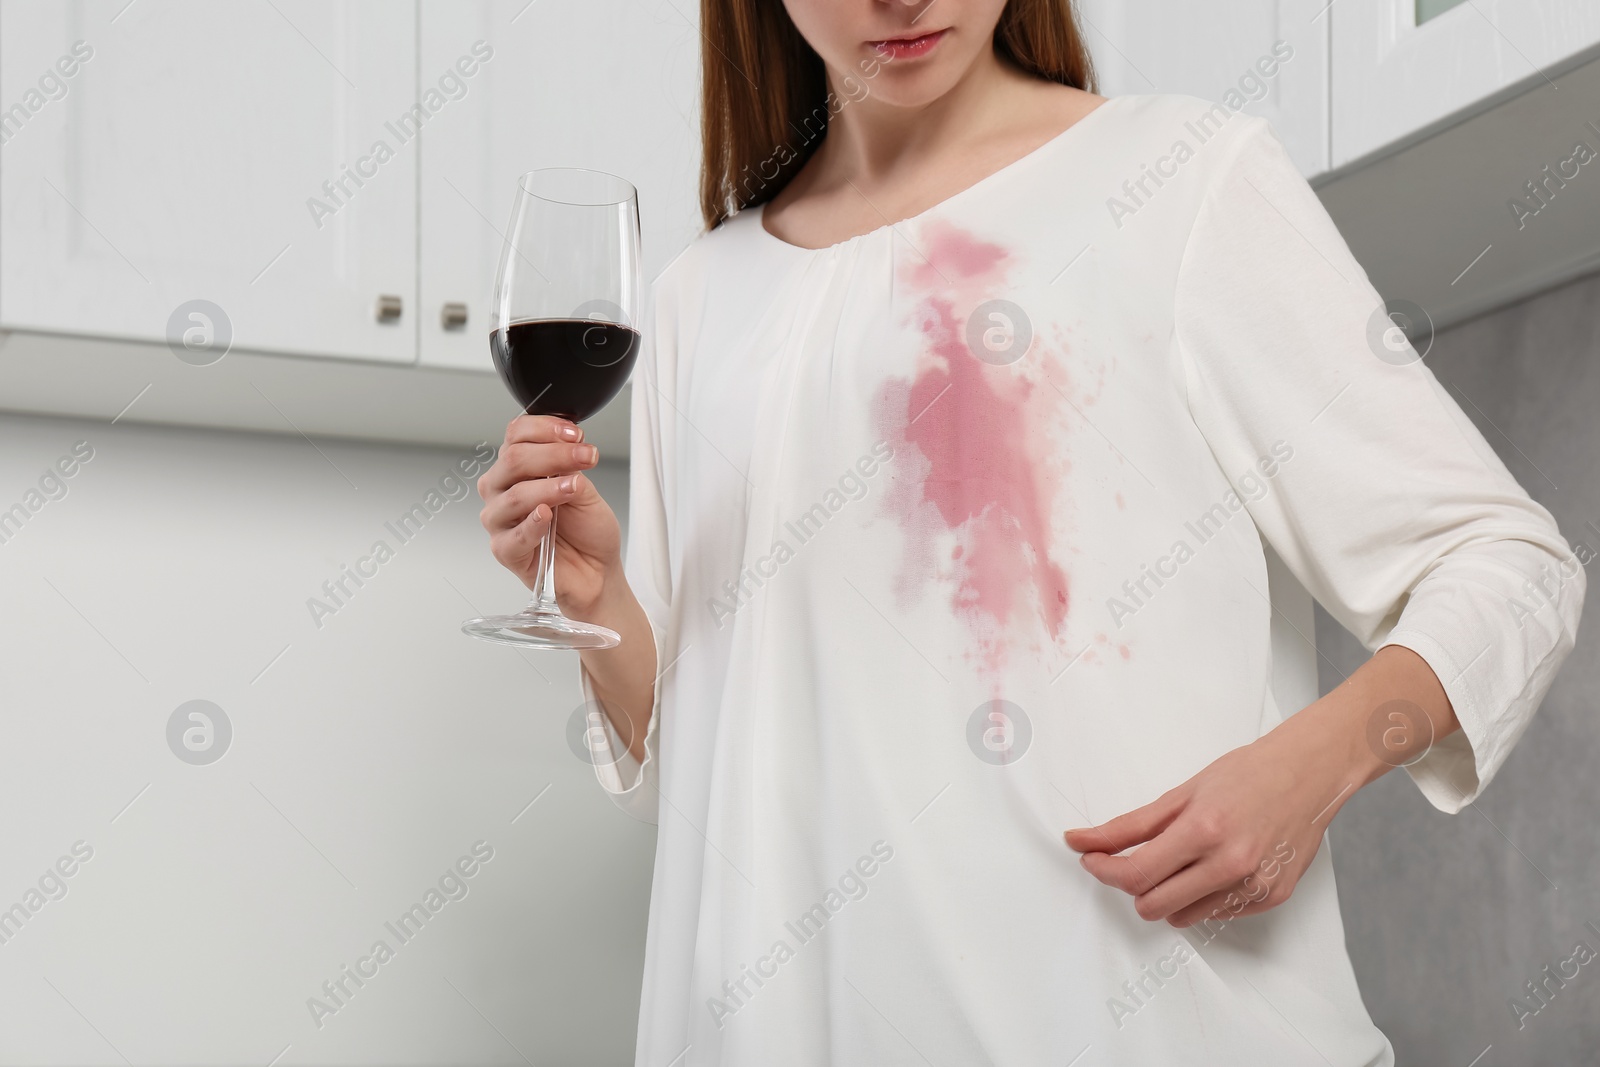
[1066,645,1458,926]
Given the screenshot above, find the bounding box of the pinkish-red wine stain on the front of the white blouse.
[877,222,1069,669]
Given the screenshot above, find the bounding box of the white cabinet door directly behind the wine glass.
[419,0,701,371]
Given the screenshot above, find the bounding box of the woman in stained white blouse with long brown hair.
[480,0,1584,1067]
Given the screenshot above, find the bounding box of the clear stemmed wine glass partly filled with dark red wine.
[461,168,640,649]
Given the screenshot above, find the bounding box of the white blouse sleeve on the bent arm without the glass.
[1174,115,1586,813]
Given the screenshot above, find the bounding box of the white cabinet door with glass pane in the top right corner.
[1330,0,1600,166]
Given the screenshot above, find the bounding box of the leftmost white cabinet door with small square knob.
[0,0,416,362]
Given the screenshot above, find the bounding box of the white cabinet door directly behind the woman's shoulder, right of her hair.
[1078,0,1331,178]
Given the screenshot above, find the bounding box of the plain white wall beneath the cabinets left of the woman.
[0,406,654,1065]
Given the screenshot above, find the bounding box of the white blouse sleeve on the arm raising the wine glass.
[579,278,672,822]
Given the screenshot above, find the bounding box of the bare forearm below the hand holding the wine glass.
[576,568,656,761]
